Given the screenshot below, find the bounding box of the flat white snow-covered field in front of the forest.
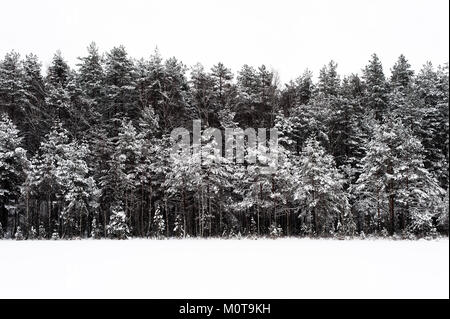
[0,239,449,299]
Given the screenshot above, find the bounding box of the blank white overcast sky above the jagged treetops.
[0,0,449,81]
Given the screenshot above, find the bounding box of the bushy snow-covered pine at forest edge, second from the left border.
[22,123,99,237]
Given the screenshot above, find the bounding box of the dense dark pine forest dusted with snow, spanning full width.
[0,44,449,239]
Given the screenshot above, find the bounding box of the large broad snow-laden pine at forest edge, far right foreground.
[356,118,444,234]
